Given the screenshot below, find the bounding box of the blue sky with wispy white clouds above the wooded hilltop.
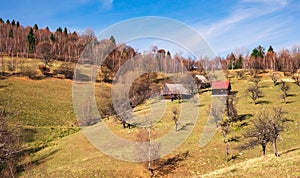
[0,0,300,56]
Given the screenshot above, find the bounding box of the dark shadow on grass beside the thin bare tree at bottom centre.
[154,151,189,177]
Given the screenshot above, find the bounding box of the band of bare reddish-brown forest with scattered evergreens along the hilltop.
[0,18,300,78]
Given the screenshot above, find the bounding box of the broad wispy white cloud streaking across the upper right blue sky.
[199,0,288,53]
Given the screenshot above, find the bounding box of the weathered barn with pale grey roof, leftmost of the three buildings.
[161,83,191,100]
